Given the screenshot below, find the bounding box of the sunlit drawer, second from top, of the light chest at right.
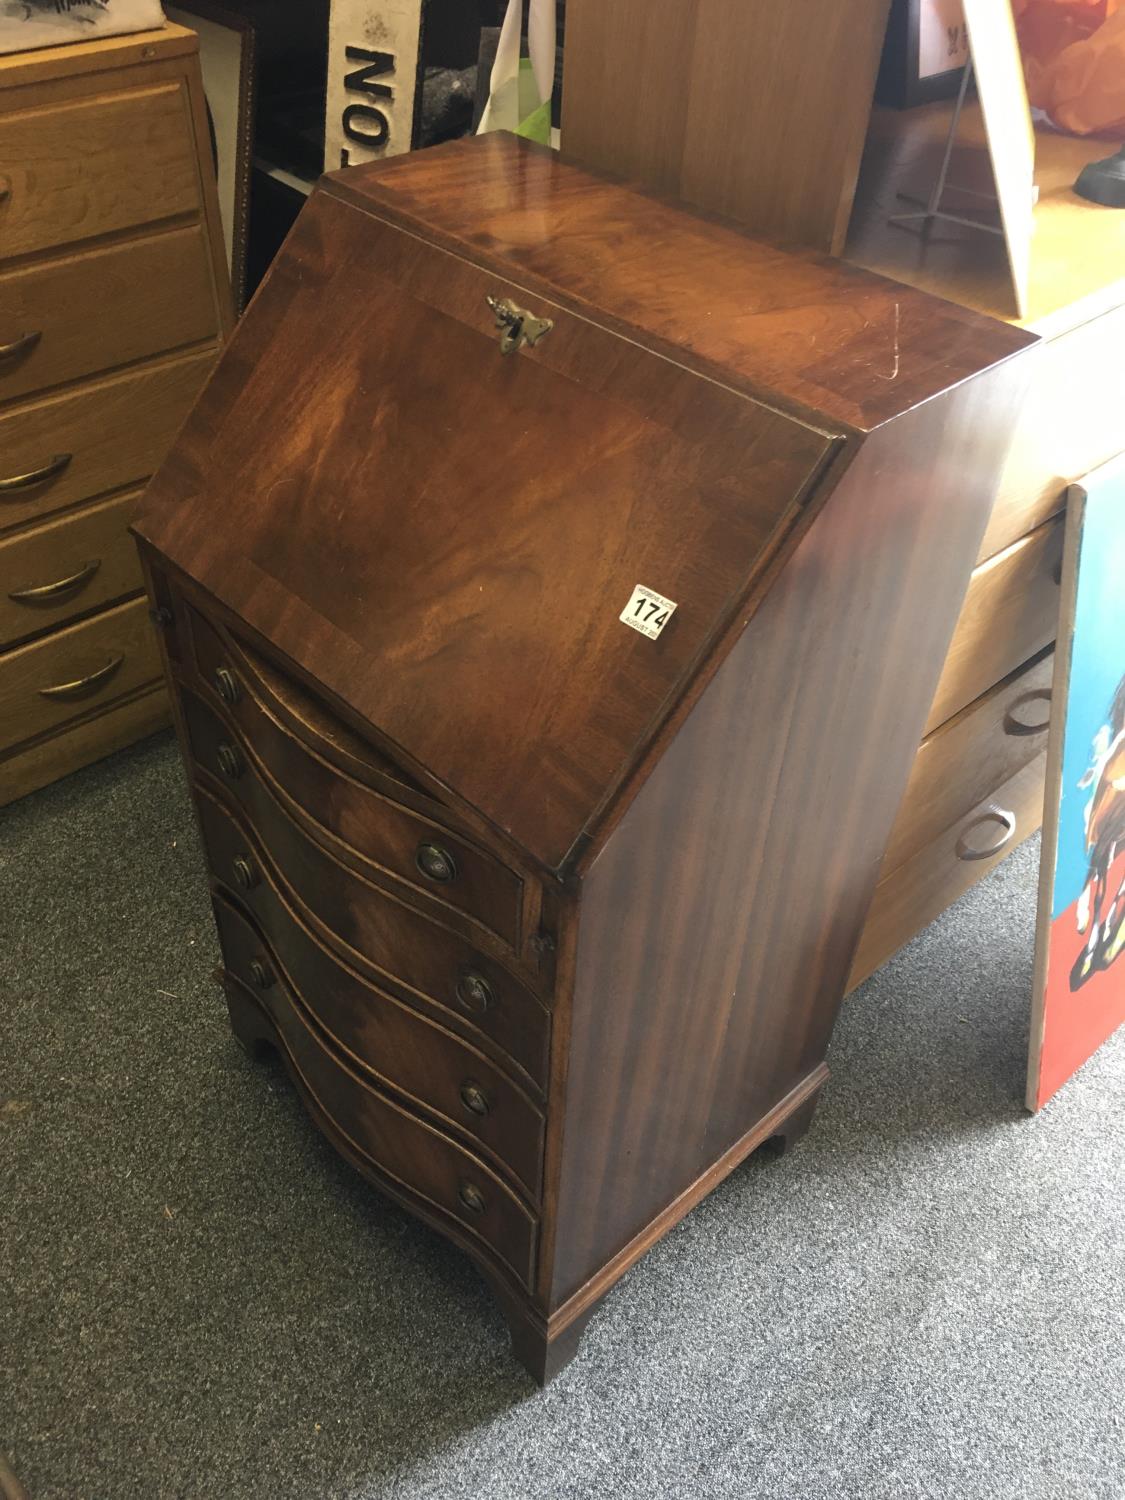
[926,516,1065,735]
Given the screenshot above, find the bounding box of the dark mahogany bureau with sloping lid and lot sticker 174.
[135,135,1034,1380]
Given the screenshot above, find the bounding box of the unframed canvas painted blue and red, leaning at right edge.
[1028,459,1125,1110]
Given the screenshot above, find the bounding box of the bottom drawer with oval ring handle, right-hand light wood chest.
[848,753,1047,990]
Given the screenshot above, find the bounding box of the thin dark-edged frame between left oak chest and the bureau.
[165,0,257,312]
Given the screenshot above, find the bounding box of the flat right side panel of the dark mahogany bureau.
[551,360,1025,1310]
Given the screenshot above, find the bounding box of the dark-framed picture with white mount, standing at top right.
[875,0,969,110]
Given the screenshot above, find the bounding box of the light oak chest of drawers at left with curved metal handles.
[0,26,231,804]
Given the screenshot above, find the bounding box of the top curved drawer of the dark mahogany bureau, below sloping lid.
[185,612,524,948]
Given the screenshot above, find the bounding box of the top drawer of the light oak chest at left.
[0,83,201,257]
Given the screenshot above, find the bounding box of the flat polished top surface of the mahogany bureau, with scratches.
[325,132,1035,431]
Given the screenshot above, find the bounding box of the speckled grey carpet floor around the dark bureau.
[0,737,1125,1500]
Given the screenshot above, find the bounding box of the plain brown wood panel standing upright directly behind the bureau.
[563,0,888,254]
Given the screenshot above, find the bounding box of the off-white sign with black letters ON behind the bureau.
[333,0,423,173]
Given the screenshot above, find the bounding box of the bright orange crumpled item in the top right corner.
[1013,0,1125,135]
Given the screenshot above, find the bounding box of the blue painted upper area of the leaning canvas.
[1052,462,1125,917]
